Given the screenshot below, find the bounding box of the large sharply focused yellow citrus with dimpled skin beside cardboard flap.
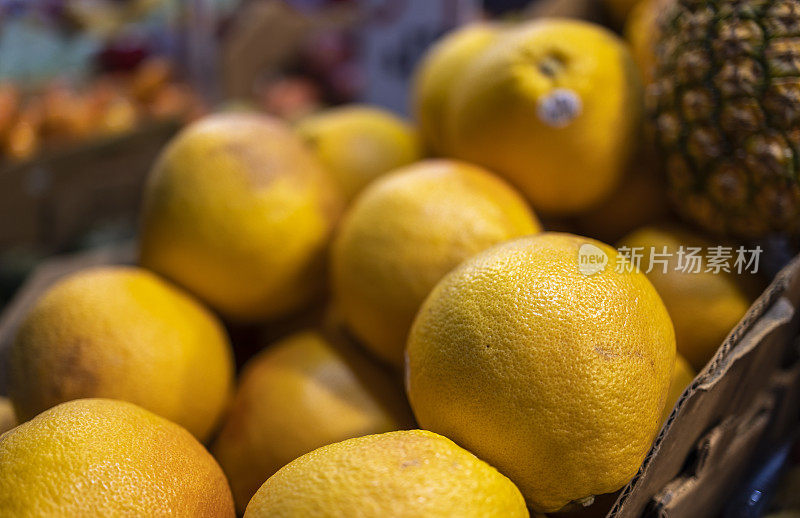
[406,233,675,512]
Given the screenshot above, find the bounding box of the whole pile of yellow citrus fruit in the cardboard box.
[0,9,750,518]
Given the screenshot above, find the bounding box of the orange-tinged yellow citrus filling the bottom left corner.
[0,399,236,518]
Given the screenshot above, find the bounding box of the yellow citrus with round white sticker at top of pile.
[424,20,642,215]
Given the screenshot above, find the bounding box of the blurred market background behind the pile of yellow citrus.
[0,0,604,304]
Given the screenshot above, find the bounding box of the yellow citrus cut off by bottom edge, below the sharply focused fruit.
[244,430,528,518]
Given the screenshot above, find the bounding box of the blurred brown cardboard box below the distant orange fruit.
[0,126,178,252]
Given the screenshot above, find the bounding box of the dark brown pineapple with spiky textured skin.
[647,0,800,238]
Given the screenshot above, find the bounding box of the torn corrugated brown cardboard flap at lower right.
[608,258,800,518]
